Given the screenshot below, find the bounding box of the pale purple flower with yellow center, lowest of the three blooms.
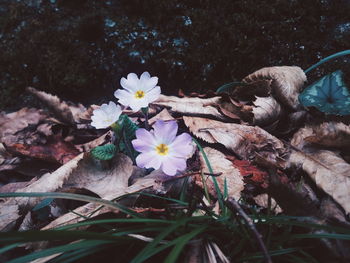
[132,120,194,176]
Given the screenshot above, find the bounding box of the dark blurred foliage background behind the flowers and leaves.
[0,0,350,110]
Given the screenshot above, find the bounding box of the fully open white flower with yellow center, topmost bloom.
[114,72,160,111]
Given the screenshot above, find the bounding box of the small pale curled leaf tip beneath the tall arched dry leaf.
[252,96,282,126]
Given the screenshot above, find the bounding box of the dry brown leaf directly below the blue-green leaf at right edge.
[291,122,350,149]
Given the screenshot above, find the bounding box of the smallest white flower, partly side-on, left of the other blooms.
[91,101,122,129]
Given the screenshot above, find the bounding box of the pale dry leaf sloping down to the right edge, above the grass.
[289,149,350,214]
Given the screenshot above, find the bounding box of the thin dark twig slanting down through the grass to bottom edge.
[225,198,272,263]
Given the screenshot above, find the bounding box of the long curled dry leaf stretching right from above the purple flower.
[183,116,285,162]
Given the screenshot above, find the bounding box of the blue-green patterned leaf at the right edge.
[299,70,350,115]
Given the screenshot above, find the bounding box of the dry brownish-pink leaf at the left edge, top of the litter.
[0,108,48,144]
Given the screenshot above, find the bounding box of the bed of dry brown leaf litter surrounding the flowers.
[0,66,350,262]
